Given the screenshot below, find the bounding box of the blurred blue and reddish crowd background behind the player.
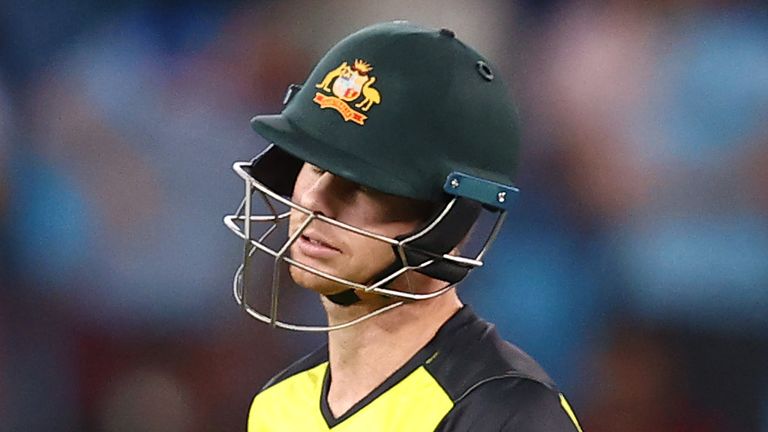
[0,0,768,432]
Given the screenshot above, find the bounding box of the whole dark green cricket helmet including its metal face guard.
[225,21,519,330]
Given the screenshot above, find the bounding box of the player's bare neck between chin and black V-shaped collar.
[324,289,462,417]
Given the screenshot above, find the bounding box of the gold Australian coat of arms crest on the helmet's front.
[313,60,381,125]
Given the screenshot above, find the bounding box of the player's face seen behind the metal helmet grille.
[290,163,433,295]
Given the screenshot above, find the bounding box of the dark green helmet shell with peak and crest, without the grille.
[251,21,519,208]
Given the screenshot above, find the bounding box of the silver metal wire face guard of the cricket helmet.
[224,162,506,332]
